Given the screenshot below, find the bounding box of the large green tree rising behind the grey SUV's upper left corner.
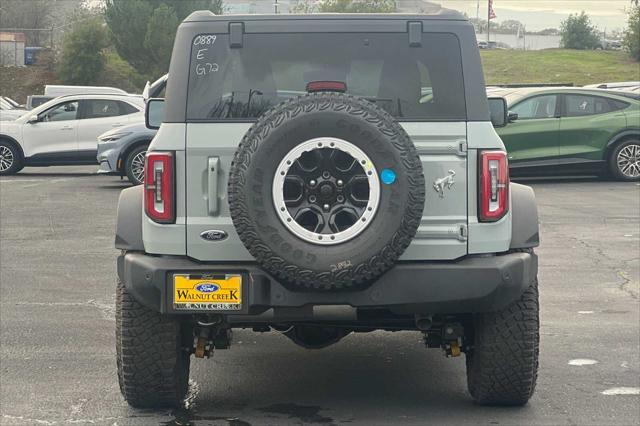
[104,0,223,79]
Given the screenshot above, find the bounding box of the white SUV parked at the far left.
[0,95,144,175]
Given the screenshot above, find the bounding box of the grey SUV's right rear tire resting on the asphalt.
[466,279,540,405]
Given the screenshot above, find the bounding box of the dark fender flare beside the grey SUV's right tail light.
[509,183,540,249]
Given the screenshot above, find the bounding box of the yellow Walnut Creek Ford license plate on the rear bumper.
[173,274,242,311]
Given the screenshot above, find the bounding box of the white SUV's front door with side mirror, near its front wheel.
[22,100,79,163]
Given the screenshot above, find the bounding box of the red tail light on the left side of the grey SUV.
[144,152,176,223]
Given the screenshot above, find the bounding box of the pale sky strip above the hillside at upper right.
[440,0,631,31]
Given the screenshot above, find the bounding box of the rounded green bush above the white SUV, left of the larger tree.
[57,17,109,85]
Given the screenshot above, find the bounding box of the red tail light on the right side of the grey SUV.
[478,151,509,222]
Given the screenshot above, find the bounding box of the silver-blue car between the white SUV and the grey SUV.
[97,121,156,185]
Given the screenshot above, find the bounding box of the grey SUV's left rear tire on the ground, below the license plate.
[116,281,189,408]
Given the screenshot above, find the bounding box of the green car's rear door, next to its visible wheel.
[558,93,628,163]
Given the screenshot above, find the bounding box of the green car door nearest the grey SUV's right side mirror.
[497,93,560,168]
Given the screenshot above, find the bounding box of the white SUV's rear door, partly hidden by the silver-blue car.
[78,99,137,159]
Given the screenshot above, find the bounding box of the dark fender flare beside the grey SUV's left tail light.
[115,185,144,251]
